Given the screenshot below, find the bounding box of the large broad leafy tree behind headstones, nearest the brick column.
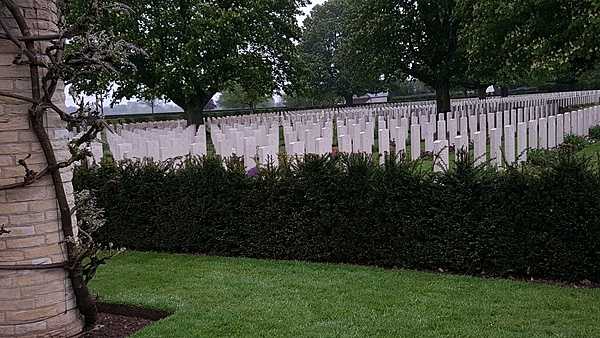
[102,0,306,122]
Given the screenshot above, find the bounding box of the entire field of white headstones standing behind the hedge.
[103,92,600,170]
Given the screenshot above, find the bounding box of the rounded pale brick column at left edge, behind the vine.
[0,0,82,337]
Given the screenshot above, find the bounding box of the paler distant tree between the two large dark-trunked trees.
[300,0,390,104]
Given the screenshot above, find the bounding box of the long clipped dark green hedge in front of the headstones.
[74,152,600,282]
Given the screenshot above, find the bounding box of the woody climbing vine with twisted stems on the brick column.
[0,0,143,327]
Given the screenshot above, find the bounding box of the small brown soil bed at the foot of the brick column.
[81,303,170,338]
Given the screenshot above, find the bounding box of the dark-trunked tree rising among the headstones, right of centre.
[351,0,465,112]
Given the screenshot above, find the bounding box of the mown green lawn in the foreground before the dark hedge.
[92,252,600,337]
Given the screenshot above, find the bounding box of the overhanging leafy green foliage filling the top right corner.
[462,0,600,92]
